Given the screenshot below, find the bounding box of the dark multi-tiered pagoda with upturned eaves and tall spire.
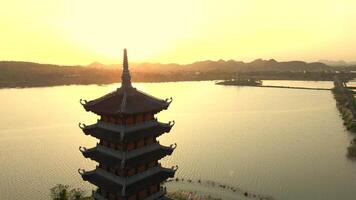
[78,49,178,200]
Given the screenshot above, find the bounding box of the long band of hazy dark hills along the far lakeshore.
[0,59,344,87]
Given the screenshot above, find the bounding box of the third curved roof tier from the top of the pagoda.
[79,143,177,169]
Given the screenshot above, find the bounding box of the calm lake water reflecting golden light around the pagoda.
[0,81,356,200]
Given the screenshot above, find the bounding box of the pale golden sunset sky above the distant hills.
[0,0,356,65]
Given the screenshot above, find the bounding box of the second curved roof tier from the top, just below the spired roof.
[79,120,174,142]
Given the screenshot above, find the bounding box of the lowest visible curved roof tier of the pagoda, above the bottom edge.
[78,166,178,197]
